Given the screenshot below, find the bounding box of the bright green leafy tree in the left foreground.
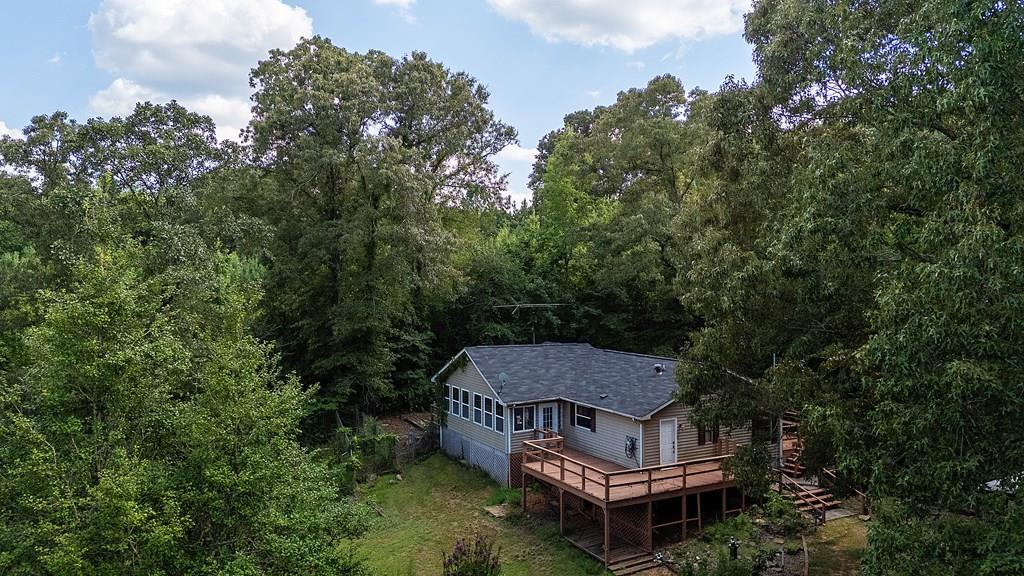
[0,190,360,574]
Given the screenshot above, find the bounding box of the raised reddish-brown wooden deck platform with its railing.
[522,439,733,505]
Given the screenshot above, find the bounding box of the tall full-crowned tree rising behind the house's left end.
[247,38,515,411]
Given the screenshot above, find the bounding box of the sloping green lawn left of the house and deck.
[357,454,606,576]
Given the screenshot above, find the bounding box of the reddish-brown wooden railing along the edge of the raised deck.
[522,437,731,502]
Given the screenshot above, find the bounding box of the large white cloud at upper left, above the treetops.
[89,0,312,138]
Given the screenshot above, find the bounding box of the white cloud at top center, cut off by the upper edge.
[487,0,751,52]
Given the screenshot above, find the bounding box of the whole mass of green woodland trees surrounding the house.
[0,0,1024,575]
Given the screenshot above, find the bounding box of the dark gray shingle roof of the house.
[466,343,677,418]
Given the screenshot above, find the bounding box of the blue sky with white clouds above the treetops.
[0,0,755,201]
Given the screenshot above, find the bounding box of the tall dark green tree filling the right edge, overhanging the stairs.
[683,0,1024,574]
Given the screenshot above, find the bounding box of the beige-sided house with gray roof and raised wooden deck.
[433,343,751,566]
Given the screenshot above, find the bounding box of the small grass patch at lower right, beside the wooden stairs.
[807,517,867,576]
